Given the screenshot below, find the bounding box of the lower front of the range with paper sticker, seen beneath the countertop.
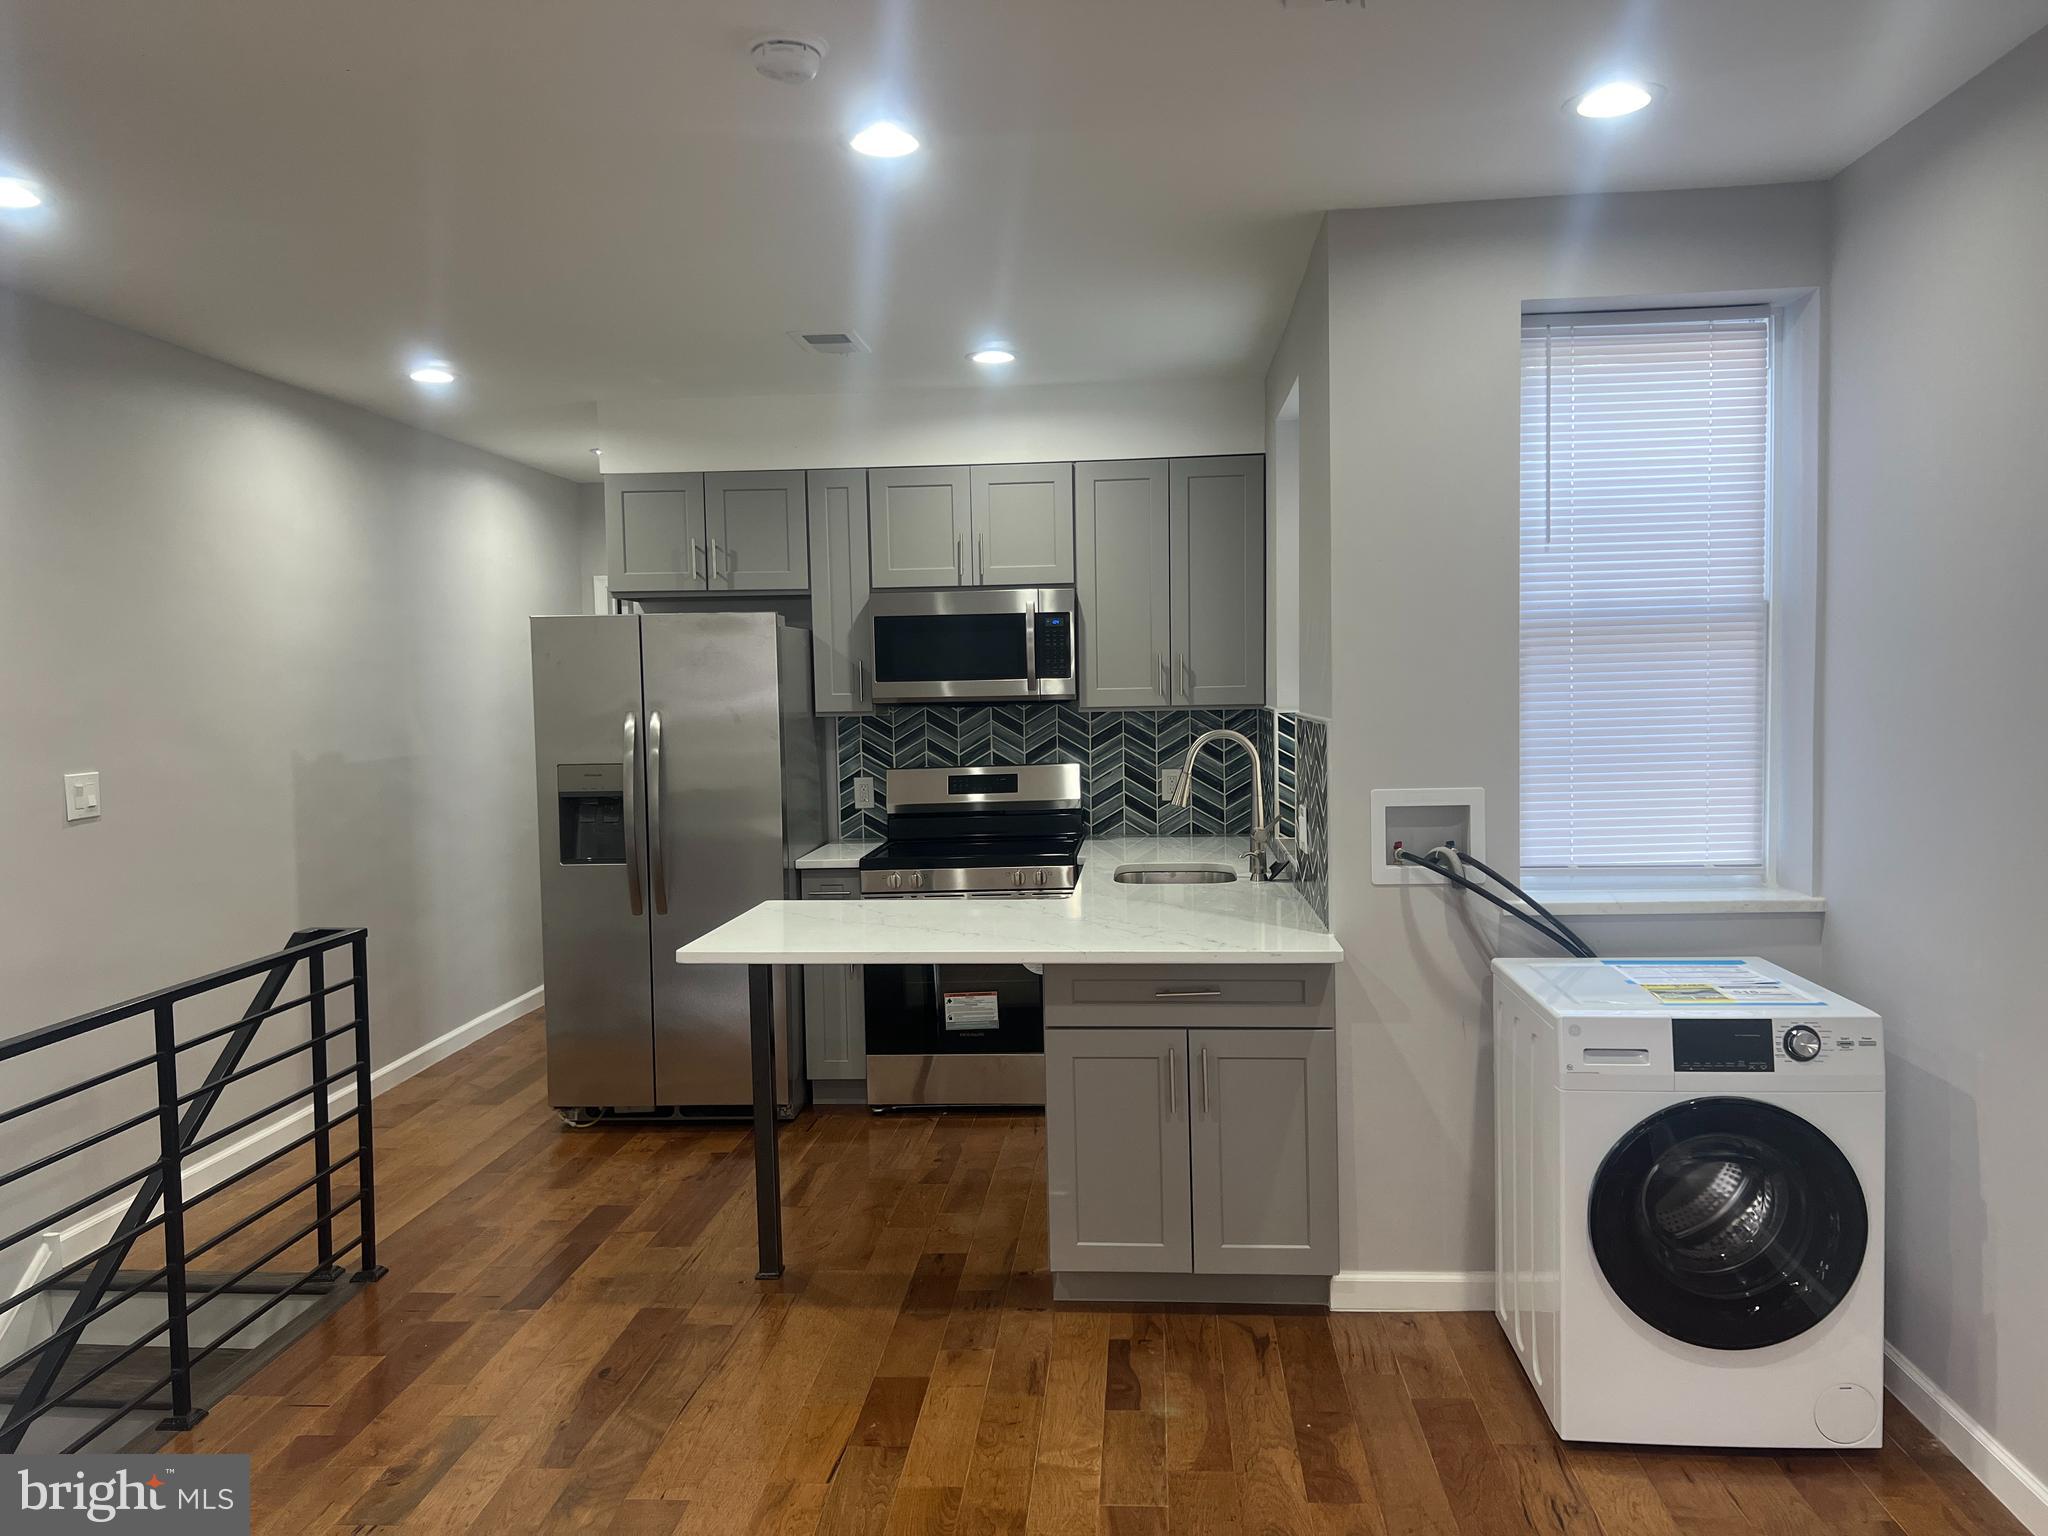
[864,965,1044,1108]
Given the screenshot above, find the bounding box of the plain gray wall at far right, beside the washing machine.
[1823,20,2048,1475]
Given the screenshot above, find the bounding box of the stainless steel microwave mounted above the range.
[868,586,1077,705]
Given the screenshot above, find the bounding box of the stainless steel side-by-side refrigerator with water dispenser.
[532,612,825,1118]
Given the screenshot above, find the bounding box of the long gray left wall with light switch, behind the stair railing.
[0,291,578,1220]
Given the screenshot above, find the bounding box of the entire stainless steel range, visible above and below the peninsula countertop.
[860,764,1087,1110]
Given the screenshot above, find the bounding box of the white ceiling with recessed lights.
[0,0,2048,477]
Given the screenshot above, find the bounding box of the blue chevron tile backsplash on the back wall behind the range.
[840,705,1272,838]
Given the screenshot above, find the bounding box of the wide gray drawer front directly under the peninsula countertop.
[1044,965,1333,1030]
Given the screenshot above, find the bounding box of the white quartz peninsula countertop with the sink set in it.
[676,838,1343,965]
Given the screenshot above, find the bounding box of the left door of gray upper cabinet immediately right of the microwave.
[1073,459,1174,709]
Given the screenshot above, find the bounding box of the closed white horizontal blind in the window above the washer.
[1522,309,1772,872]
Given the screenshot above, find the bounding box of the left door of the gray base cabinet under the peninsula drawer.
[1044,1030,1194,1274]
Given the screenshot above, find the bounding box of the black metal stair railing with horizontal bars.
[0,928,383,1454]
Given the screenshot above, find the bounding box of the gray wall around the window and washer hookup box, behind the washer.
[1318,186,1827,1272]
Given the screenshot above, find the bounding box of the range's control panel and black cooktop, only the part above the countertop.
[860,762,1087,897]
